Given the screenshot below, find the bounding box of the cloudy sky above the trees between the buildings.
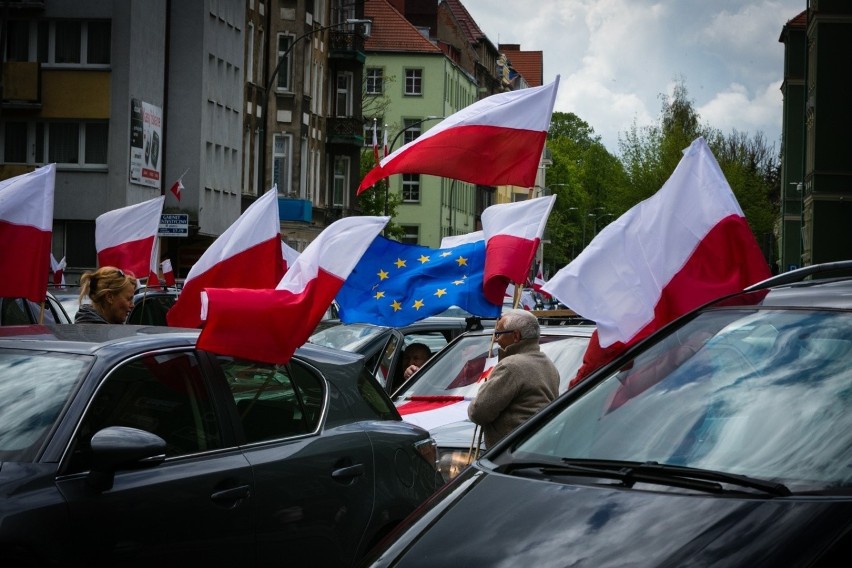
[462,0,806,153]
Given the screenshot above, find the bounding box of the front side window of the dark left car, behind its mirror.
[71,352,222,471]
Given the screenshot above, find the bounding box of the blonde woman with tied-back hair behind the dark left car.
[74,266,136,323]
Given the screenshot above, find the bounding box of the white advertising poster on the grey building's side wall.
[130,99,163,189]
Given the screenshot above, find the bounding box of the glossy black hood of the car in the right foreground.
[375,468,852,568]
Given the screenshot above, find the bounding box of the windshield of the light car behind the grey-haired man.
[396,334,589,399]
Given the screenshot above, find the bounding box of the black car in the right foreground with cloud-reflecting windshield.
[368,263,852,568]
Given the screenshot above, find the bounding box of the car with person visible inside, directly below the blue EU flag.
[308,316,494,392]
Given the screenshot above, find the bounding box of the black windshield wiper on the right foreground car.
[498,458,791,497]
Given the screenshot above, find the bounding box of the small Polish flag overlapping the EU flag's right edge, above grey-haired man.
[482,195,556,305]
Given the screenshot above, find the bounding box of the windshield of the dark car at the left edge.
[0,351,90,462]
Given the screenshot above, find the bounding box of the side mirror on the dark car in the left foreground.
[89,426,166,491]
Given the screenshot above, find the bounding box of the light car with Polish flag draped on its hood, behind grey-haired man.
[391,325,594,481]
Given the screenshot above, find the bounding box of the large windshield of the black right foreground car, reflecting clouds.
[510,309,852,490]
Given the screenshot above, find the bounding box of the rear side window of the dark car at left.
[219,357,324,443]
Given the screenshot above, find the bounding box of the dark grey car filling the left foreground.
[0,324,440,566]
